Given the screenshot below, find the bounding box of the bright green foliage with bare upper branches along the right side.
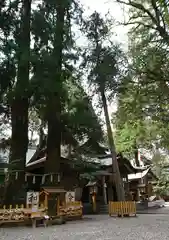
[113,0,169,154]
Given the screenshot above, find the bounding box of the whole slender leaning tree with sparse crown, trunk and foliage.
[85,12,125,201]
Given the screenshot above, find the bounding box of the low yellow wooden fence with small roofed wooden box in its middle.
[0,187,82,227]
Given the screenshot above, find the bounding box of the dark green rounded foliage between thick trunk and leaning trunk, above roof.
[63,80,103,141]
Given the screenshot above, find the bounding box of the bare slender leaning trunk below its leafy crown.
[101,90,125,201]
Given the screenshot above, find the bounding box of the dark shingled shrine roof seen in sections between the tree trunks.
[27,139,150,174]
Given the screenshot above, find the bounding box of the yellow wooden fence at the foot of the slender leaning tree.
[109,202,136,217]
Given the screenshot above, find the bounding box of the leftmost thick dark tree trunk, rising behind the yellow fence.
[5,0,31,203]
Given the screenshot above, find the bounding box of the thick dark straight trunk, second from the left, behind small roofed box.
[45,0,65,184]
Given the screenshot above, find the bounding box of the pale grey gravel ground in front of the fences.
[0,214,169,240]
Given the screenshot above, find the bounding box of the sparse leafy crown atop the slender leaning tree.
[82,12,123,97]
